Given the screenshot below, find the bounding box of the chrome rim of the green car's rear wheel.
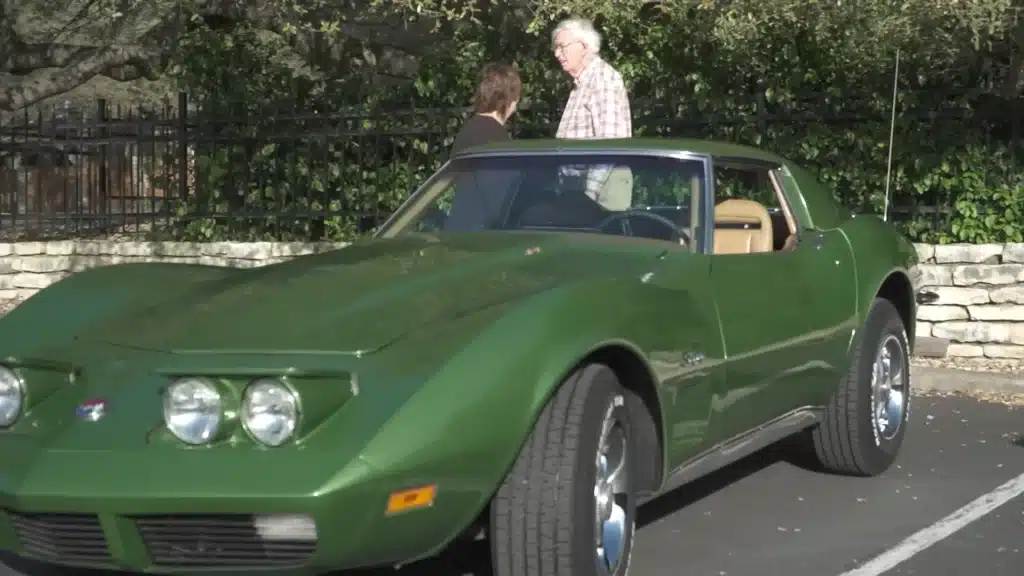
[871,334,907,444]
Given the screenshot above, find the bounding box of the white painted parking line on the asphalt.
[839,475,1024,576]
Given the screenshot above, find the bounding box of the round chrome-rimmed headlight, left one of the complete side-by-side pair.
[164,376,224,446]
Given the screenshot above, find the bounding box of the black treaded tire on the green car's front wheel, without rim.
[488,364,636,576]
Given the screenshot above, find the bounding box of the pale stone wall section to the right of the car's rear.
[916,244,1024,360]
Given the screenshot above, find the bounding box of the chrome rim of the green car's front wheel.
[594,399,632,574]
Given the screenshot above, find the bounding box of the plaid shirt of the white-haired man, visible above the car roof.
[555,56,633,138]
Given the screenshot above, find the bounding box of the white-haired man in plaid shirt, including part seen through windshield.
[551,18,633,211]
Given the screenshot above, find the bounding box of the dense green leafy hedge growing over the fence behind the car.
[161,0,1024,242]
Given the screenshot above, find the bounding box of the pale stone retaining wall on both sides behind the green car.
[0,241,1024,359]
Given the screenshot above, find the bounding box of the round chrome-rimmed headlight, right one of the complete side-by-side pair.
[239,377,302,448]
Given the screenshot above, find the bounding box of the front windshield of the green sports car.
[379,153,705,245]
